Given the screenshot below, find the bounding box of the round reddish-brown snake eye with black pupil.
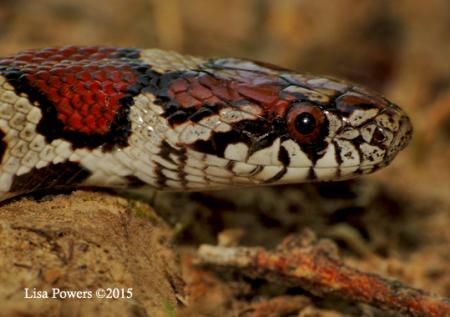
[287,102,325,143]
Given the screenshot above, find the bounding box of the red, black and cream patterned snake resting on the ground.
[0,46,412,200]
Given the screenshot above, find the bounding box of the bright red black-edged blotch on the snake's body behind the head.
[2,47,137,135]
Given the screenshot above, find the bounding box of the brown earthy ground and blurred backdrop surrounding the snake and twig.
[0,0,450,316]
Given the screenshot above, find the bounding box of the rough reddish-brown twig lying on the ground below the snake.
[199,231,450,317]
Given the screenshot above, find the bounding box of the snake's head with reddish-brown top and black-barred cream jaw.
[133,55,412,189]
